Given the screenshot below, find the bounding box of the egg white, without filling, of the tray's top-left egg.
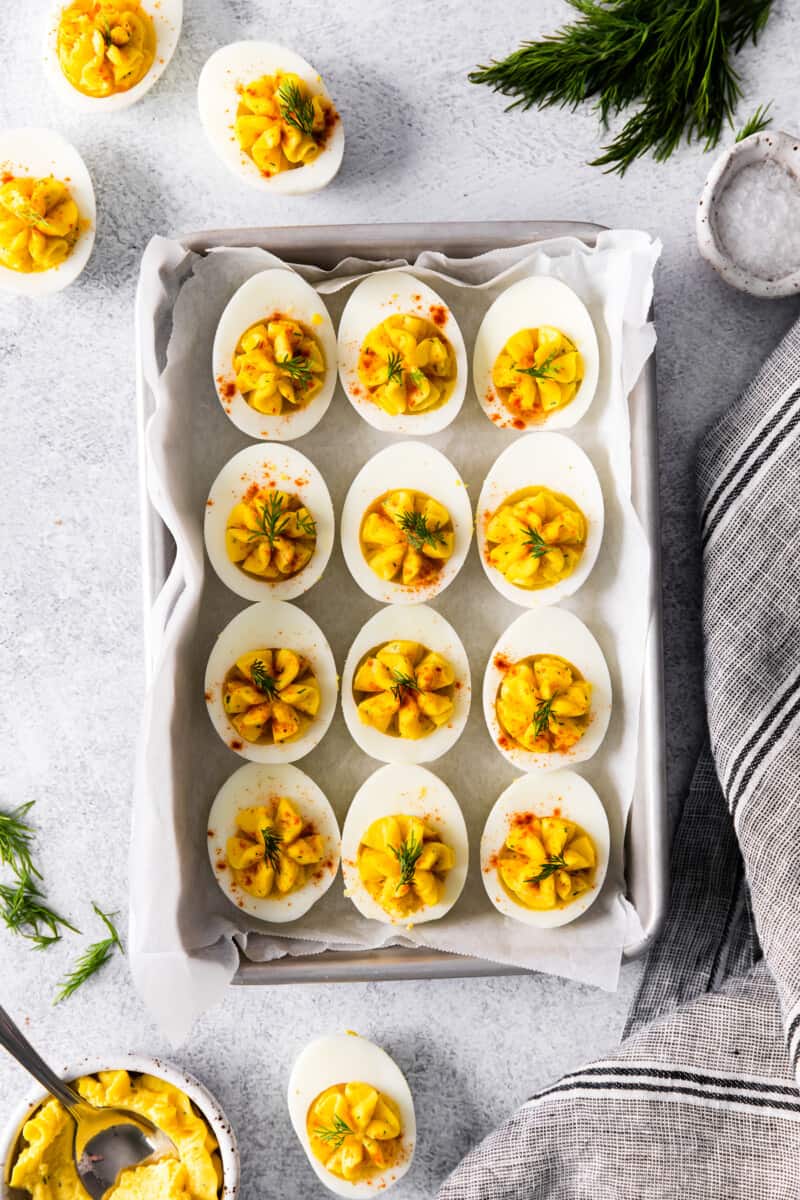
[212,268,336,442]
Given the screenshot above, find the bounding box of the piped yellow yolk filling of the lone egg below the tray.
[306,1084,403,1183]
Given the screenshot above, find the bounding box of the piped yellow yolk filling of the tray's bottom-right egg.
[498,812,597,910]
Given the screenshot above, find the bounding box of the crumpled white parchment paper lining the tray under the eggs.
[131,230,661,1038]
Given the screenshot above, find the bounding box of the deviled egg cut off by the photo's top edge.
[47,0,184,113]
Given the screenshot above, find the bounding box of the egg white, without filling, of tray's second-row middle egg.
[341,442,473,605]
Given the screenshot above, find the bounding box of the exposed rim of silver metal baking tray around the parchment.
[136,221,668,984]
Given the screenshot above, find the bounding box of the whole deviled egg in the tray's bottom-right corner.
[481,770,609,929]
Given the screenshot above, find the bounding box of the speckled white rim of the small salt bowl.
[696,130,800,299]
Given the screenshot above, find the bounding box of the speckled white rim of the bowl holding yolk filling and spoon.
[0,1051,240,1200]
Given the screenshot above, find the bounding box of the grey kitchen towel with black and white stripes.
[439,322,800,1200]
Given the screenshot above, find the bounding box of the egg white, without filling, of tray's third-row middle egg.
[342,605,471,763]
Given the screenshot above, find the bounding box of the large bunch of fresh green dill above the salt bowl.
[469,0,771,174]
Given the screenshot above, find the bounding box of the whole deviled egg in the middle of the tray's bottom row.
[342,763,469,926]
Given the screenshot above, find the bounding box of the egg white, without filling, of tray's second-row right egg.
[476,433,604,608]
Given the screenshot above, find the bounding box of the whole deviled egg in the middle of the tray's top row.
[338,270,467,437]
